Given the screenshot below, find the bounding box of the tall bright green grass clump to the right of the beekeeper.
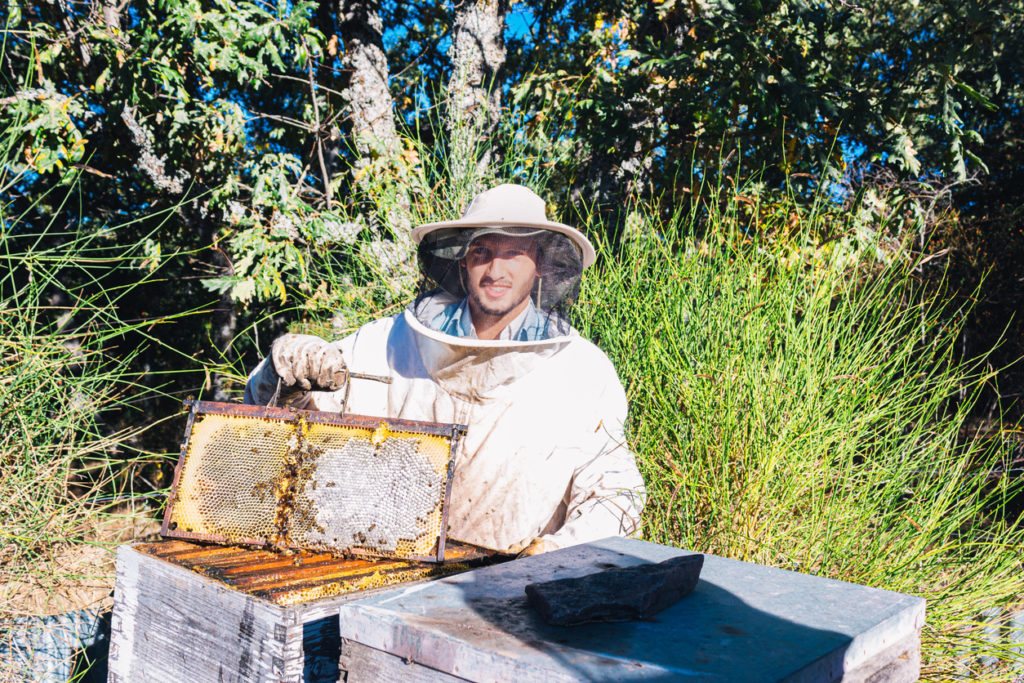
[580,193,1024,679]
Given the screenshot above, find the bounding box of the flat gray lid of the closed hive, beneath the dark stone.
[340,538,925,682]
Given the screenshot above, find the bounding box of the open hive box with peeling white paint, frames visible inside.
[108,541,478,683]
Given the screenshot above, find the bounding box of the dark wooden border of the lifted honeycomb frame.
[160,398,467,562]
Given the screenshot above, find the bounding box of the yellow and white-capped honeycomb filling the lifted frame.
[165,411,455,559]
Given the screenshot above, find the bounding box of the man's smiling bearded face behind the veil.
[462,234,538,317]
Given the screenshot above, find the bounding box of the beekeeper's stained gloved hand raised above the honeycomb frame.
[270,335,347,391]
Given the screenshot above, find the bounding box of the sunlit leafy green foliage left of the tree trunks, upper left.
[0,0,344,313]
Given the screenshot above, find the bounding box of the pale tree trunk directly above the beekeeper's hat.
[447,0,508,187]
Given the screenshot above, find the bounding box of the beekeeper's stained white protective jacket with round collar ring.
[246,294,644,550]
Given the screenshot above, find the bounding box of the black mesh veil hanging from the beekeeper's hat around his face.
[413,227,583,339]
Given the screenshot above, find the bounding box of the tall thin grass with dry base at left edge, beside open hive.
[0,147,175,620]
